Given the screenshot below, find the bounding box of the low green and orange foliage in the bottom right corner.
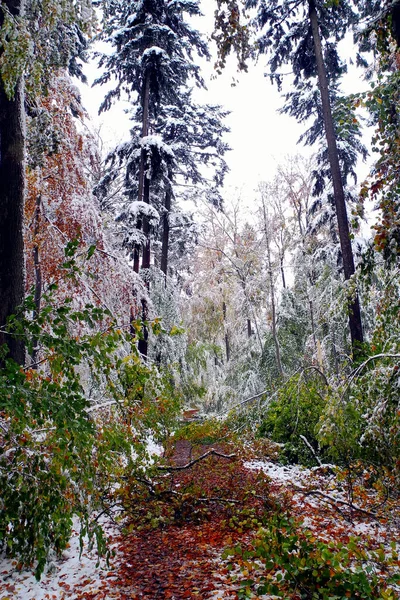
[225,515,399,600]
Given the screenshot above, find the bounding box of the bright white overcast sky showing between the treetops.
[78,0,372,209]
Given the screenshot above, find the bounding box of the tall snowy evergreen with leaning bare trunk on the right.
[219,0,363,352]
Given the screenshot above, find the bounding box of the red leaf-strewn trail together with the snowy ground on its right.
[69,440,398,600]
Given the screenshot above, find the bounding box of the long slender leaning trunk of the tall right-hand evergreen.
[308,0,363,355]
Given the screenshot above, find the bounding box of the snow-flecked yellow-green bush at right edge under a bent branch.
[318,268,400,479]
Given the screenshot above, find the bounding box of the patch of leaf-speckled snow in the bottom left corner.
[0,520,116,600]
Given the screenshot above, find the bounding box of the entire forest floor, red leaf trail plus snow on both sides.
[0,440,400,600]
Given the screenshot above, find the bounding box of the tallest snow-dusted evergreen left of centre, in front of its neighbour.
[97,0,208,272]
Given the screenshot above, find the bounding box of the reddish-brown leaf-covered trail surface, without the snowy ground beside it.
[76,440,254,600]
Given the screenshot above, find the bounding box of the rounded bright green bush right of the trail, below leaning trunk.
[258,372,328,465]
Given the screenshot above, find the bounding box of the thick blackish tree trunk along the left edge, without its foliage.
[0,0,25,365]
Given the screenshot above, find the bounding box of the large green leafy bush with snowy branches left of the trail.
[0,253,180,578]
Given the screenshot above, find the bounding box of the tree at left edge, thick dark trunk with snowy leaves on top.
[0,0,92,364]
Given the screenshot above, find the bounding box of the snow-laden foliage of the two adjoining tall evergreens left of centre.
[96,0,227,273]
